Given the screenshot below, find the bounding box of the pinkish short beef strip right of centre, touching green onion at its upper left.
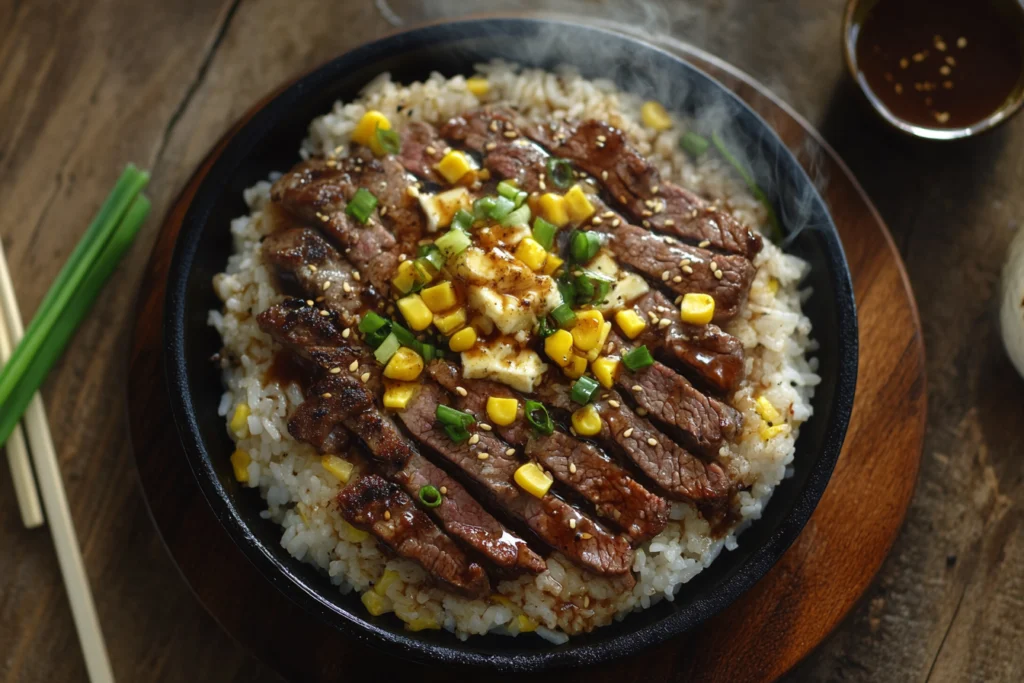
[612,335,742,456]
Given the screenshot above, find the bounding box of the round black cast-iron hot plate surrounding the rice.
[164,18,857,671]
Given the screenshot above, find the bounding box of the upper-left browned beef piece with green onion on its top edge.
[270,159,398,294]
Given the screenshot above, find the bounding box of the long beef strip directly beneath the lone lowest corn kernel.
[398,384,633,574]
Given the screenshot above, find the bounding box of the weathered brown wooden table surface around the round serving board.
[0,0,1024,683]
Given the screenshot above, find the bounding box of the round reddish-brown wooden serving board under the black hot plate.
[129,27,926,683]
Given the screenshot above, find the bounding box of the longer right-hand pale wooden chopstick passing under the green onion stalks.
[0,244,114,683]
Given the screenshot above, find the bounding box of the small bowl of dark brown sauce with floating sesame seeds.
[847,0,1024,138]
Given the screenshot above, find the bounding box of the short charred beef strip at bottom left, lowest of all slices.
[337,474,490,598]
